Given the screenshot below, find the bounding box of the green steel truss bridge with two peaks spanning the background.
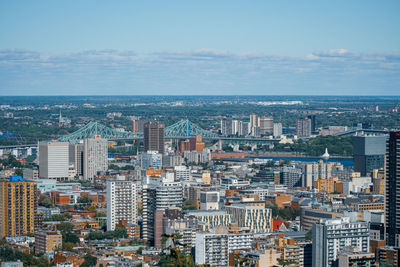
[58,119,280,144]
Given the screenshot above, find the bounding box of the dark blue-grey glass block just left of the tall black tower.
[353,136,387,176]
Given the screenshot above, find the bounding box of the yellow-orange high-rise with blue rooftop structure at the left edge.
[0,176,38,238]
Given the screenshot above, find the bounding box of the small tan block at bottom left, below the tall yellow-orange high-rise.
[35,231,62,254]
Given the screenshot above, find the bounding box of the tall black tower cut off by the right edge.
[385,132,400,247]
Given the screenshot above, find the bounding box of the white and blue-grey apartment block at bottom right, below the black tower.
[312,217,370,267]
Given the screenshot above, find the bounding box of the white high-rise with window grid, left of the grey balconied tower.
[107,176,137,231]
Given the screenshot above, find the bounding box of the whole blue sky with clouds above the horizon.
[0,0,400,95]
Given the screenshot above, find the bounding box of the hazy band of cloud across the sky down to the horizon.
[0,49,400,94]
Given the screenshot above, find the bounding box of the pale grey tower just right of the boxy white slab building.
[83,135,108,182]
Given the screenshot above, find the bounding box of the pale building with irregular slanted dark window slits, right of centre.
[226,204,272,233]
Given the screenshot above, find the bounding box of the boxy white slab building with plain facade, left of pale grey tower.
[39,141,69,181]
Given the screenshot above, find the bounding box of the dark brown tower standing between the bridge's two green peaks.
[144,121,165,154]
